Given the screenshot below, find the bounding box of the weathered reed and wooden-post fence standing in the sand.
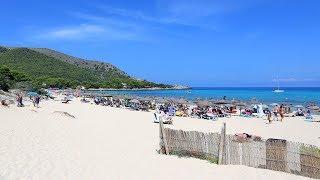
[159,122,320,179]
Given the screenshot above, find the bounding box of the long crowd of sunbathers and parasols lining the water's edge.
[82,93,311,123]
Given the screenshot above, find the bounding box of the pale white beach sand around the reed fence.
[0,101,320,180]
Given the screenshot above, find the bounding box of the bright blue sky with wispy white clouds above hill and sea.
[0,0,320,86]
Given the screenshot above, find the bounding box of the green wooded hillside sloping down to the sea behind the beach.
[0,47,171,90]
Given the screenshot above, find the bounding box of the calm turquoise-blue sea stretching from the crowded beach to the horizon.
[94,88,320,104]
